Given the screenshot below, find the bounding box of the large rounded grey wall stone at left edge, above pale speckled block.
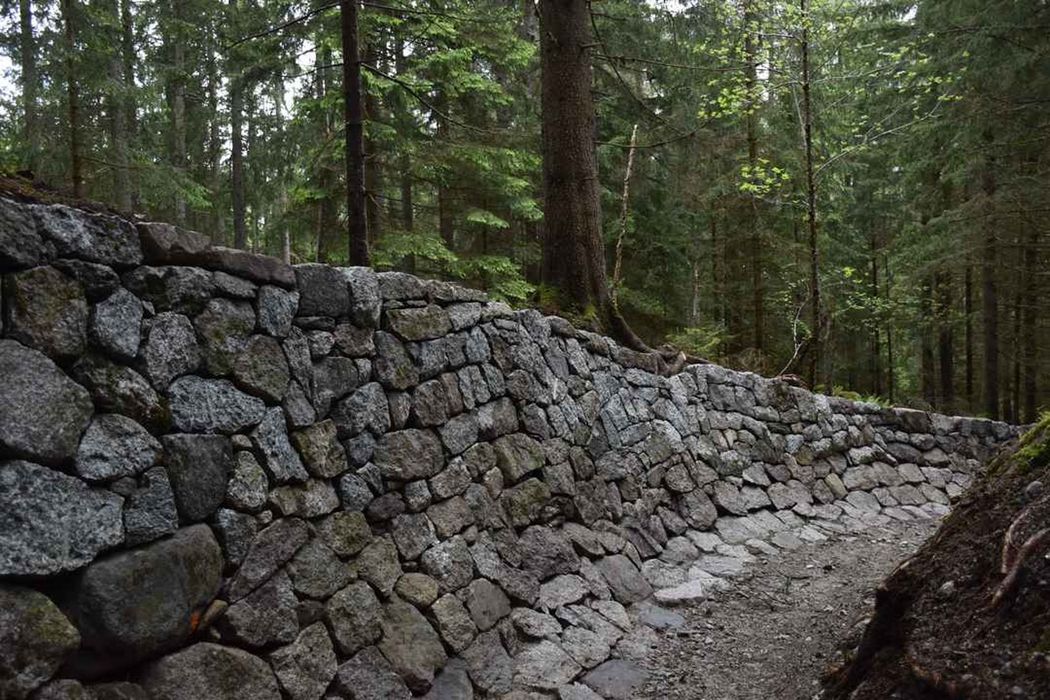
[0,340,91,464]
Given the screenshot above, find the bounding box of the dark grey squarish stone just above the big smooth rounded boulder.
[164,434,233,523]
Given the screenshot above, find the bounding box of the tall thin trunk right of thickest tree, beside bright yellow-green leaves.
[799,0,824,386]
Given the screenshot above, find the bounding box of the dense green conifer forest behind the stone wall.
[0,0,1050,421]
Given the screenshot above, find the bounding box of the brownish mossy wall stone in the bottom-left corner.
[0,585,80,700]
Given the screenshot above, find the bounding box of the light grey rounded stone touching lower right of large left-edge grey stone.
[77,413,161,482]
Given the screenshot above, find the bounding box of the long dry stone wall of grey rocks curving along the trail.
[0,199,1016,700]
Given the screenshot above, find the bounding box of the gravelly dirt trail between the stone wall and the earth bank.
[642,521,938,700]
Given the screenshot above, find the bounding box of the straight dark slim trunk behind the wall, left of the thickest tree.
[339,0,369,266]
